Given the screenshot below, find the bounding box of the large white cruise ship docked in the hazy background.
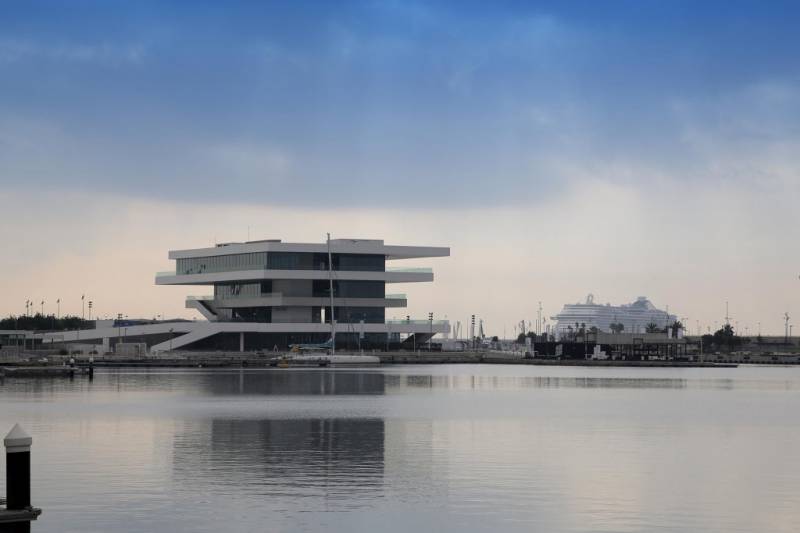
[551,294,677,337]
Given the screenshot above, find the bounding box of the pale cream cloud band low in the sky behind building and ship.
[0,176,800,334]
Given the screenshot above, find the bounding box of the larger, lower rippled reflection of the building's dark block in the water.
[173,418,385,506]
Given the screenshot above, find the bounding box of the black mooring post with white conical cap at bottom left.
[0,424,42,533]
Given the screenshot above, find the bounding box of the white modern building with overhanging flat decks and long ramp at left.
[37,239,450,352]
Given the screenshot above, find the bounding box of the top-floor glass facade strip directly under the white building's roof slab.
[175,252,386,276]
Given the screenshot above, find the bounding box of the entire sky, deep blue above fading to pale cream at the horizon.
[0,0,800,335]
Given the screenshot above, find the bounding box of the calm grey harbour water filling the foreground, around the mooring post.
[0,365,800,533]
